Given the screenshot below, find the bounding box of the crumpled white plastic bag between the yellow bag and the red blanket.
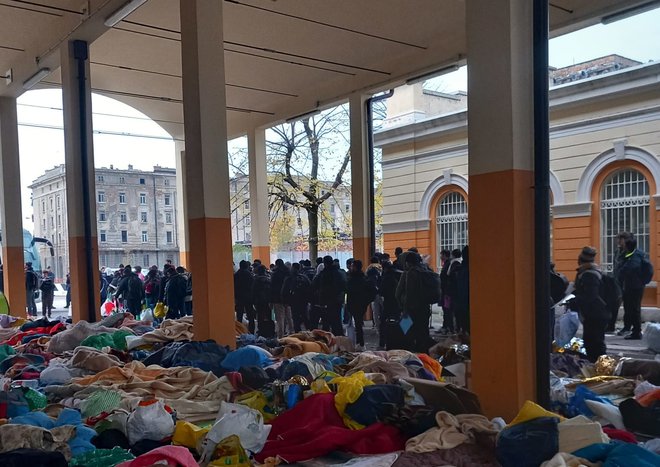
[199,401,272,465]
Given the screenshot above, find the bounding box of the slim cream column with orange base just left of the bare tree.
[248,128,270,264]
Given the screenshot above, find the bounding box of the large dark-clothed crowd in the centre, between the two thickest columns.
[234,247,469,351]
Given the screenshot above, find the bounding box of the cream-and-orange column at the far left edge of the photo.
[0,97,26,316]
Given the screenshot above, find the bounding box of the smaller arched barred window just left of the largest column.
[435,191,468,256]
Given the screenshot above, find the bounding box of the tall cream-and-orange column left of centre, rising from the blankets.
[180,0,236,347]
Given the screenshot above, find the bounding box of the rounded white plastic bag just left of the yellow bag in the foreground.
[126,401,174,446]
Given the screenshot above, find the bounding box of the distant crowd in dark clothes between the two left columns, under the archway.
[101,261,193,319]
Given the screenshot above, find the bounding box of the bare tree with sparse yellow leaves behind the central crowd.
[267,105,351,258]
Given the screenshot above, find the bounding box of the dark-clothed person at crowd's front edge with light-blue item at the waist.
[396,251,431,352]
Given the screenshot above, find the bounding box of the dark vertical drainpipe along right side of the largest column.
[533,0,552,408]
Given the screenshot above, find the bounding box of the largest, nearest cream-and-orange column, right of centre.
[466,0,536,420]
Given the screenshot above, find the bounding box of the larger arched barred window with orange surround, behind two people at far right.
[600,169,651,272]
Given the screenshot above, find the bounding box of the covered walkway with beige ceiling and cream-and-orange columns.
[0,0,649,417]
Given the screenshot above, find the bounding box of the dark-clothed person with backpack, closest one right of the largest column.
[570,246,609,362]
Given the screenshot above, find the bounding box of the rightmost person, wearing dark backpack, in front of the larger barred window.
[617,232,653,340]
